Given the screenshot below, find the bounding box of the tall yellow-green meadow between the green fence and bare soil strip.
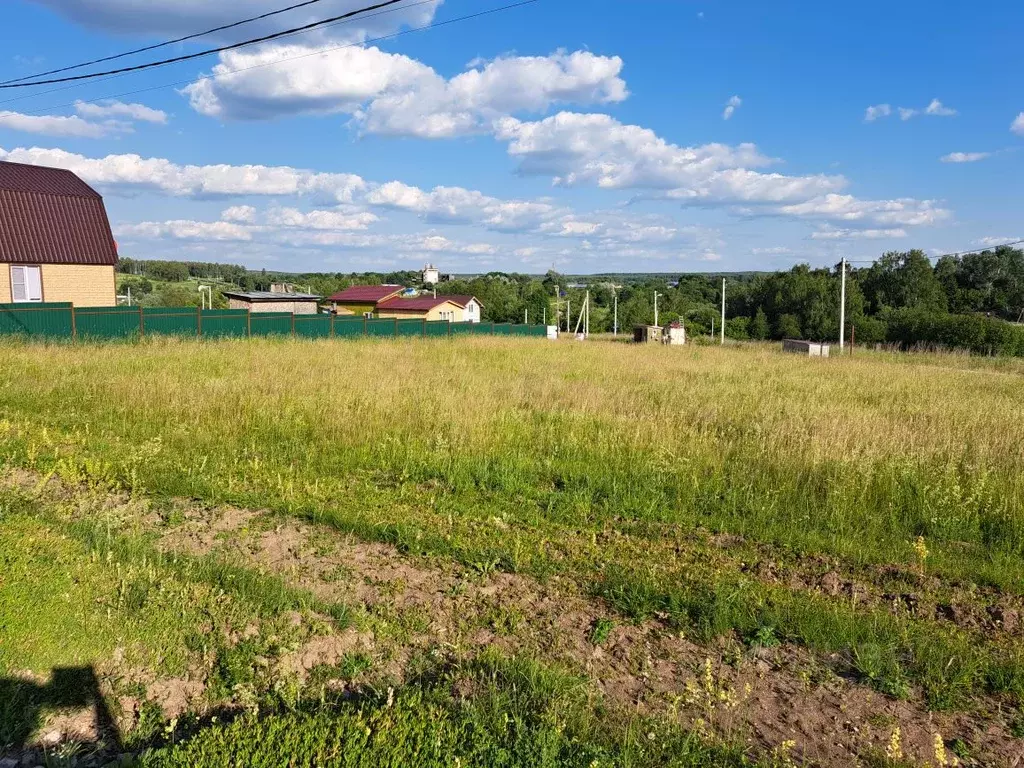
[0,339,1024,741]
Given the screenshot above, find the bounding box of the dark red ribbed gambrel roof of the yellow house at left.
[0,161,118,264]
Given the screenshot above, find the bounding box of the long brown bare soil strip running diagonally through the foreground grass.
[6,473,1024,766]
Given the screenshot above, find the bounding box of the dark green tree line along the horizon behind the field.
[119,247,1024,355]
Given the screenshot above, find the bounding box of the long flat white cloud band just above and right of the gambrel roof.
[0,147,366,203]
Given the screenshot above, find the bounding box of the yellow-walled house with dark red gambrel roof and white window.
[0,162,118,306]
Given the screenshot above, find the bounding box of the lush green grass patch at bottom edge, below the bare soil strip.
[137,654,768,768]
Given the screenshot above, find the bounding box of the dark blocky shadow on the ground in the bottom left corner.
[0,667,121,755]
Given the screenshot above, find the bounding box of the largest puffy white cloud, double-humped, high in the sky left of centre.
[183,45,628,138]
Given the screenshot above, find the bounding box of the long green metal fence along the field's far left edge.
[0,303,547,339]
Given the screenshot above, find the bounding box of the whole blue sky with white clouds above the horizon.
[0,0,1024,272]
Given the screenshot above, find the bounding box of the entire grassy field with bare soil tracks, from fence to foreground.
[0,338,1024,765]
